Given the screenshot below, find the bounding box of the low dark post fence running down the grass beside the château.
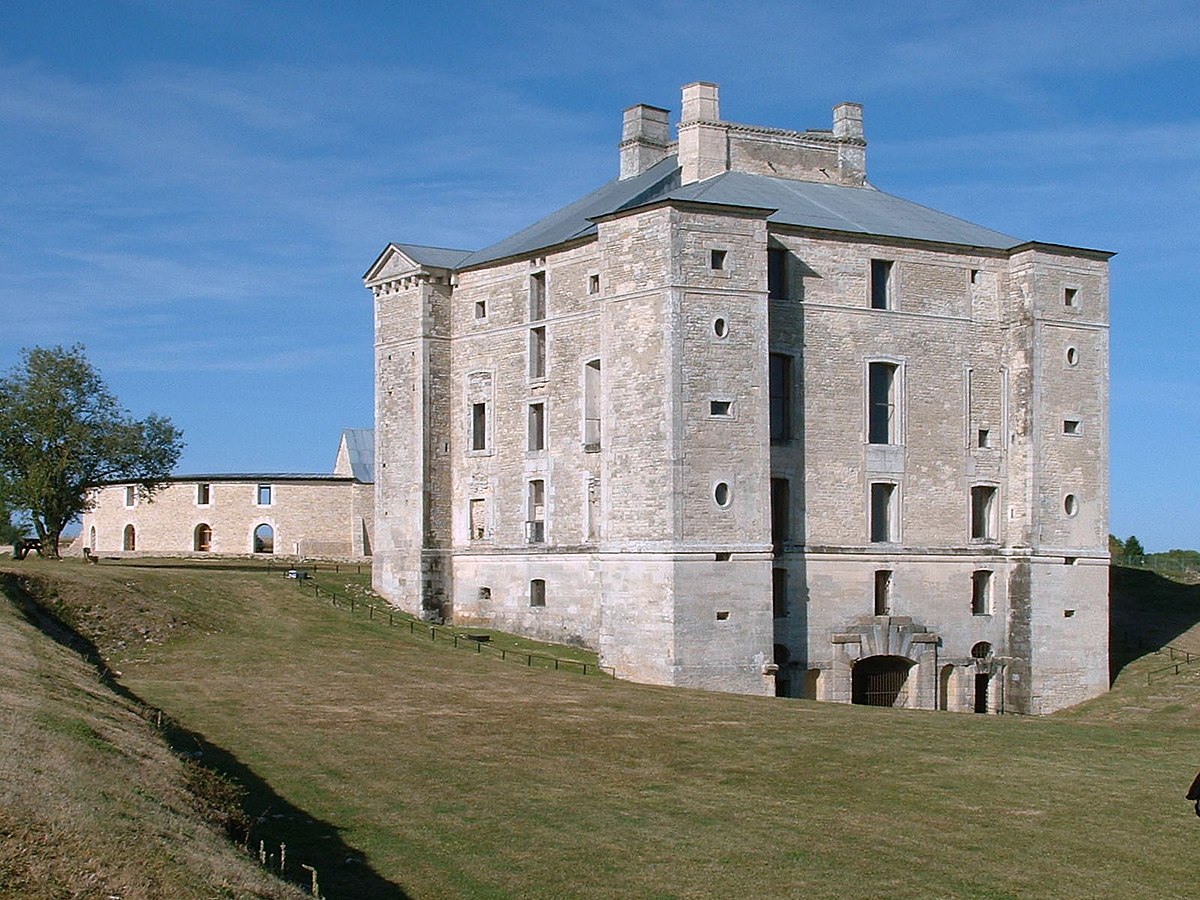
[284,571,617,678]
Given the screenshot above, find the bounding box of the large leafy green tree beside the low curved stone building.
[0,344,184,558]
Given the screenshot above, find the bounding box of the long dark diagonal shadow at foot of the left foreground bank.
[0,572,408,900]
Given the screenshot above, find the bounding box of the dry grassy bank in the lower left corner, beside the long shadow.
[0,574,301,900]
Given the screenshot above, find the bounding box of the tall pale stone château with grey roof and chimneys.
[365,83,1111,713]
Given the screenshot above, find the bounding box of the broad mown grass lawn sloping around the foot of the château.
[6,562,1200,898]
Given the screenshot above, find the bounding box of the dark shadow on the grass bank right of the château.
[1109,565,1200,684]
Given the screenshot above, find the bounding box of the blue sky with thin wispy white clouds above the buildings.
[0,0,1200,550]
